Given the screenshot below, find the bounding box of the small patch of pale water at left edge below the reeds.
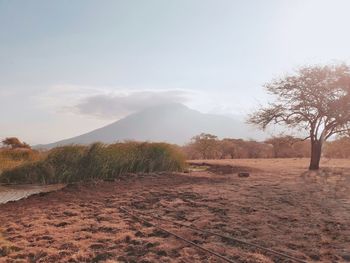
[0,184,65,204]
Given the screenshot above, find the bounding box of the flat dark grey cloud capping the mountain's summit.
[74,90,189,119]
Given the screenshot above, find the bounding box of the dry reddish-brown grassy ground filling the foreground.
[0,159,350,263]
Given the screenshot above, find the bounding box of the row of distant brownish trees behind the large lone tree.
[182,133,350,159]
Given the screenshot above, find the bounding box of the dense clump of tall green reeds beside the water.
[0,142,185,184]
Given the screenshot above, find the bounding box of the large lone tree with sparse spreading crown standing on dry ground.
[249,64,350,170]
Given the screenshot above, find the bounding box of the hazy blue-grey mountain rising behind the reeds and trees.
[36,103,263,148]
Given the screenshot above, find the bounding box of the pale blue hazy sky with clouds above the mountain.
[0,0,350,144]
